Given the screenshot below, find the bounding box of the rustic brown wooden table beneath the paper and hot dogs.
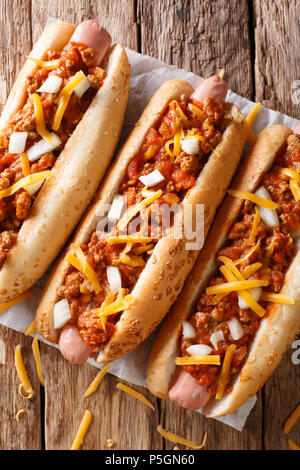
[0,0,300,449]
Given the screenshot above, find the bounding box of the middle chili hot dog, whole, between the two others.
[36,78,245,363]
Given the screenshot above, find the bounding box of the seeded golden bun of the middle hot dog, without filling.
[36,80,245,362]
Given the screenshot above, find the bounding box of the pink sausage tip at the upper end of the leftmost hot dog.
[70,20,111,65]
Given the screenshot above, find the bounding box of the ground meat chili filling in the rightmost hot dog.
[181,135,300,395]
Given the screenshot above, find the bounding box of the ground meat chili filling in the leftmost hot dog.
[0,44,105,268]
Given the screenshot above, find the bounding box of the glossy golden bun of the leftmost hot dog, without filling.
[0,23,129,303]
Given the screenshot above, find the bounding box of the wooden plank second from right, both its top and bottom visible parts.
[138,0,262,449]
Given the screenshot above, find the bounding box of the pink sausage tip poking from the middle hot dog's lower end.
[59,323,92,364]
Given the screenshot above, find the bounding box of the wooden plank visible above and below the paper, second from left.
[32,0,162,449]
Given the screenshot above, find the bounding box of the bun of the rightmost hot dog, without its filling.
[147,125,300,417]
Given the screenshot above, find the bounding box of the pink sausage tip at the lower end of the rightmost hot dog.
[169,369,211,410]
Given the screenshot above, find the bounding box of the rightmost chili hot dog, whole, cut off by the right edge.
[147,125,300,417]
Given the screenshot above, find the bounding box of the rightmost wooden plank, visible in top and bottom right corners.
[254,0,300,450]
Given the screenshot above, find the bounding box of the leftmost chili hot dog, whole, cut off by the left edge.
[0,20,129,303]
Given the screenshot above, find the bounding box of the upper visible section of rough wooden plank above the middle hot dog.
[138,0,252,98]
